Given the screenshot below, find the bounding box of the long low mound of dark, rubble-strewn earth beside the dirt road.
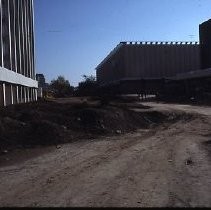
[0,99,193,150]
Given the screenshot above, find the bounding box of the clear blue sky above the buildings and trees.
[34,0,211,86]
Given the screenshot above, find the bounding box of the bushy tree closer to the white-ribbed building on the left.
[50,76,74,98]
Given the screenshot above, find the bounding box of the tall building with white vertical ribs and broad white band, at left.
[0,0,38,106]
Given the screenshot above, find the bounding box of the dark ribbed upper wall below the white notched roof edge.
[97,42,200,84]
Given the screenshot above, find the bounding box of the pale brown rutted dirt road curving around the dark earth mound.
[0,102,211,207]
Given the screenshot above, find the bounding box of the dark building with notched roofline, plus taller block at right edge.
[96,20,211,93]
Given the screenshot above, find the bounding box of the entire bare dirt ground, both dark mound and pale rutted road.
[0,98,211,207]
